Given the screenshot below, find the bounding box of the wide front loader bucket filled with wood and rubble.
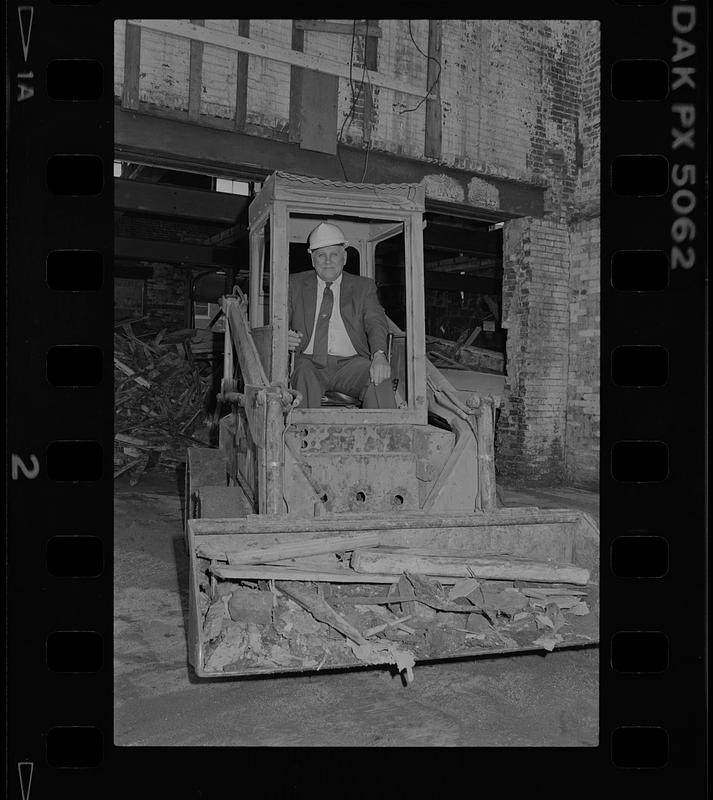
[187,508,599,681]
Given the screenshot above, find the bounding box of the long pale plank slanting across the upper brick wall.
[127,19,434,97]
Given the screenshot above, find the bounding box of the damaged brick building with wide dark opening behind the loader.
[114,19,600,486]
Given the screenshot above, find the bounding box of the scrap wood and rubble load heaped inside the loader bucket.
[197,533,598,681]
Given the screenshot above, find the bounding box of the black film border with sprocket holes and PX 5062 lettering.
[6,0,708,800]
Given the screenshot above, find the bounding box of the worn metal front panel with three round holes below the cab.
[303,453,419,512]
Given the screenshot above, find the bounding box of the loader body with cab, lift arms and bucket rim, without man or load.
[186,172,598,676]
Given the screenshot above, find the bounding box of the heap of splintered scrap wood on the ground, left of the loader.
[114,323,211,485]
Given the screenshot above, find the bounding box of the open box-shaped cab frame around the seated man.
[248,172,428,425]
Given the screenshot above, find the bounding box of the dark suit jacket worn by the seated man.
[289,269,389,358]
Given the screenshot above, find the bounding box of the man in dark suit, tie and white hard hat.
[288,222,396,408]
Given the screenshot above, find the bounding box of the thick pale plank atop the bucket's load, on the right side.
[351,550,589,586]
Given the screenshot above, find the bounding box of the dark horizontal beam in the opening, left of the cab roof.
[114,178,250,225]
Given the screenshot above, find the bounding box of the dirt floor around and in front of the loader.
[114,473,599,747]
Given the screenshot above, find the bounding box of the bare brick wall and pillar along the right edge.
[496,23,600,486]
